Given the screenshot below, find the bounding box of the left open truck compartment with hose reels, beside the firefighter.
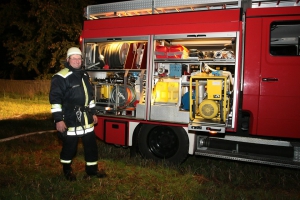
[84,36,149,117]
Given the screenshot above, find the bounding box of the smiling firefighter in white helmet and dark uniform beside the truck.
[49,47,106,181]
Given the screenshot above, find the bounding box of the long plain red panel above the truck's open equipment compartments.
[82,9,240,38]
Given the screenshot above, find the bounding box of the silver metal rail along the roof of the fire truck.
[84,0,300,20]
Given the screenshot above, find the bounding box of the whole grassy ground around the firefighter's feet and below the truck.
[0,96,300,200]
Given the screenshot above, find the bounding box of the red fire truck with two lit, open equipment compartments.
[81,0,300,168]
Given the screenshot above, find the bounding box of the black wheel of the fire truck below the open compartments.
[138,125,189,164]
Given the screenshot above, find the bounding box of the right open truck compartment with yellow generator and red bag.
[150,32,238,132]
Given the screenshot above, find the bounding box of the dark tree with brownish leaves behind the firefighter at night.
[0,0,93,79]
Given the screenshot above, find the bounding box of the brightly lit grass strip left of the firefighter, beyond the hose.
[0,96,54,139]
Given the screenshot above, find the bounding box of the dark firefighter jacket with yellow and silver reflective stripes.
[49,63,95,133]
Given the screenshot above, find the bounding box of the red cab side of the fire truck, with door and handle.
[243,8,300,138]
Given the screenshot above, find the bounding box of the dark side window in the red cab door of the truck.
[270,21,300,56]
